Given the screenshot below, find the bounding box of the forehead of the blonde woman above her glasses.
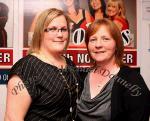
[48,15,67,26]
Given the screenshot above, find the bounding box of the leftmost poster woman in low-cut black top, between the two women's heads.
[60,0,92,31]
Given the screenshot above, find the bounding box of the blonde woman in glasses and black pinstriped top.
[5,8,78,121]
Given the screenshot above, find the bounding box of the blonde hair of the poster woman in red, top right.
[107,0,126,18]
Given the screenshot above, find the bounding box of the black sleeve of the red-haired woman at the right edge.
[124,72,150,121]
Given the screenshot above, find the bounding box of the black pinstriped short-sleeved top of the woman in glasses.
[9,55,81,121]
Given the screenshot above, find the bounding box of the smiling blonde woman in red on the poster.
[106,0,131,46]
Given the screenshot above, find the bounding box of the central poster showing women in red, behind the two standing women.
[23,0,137,66]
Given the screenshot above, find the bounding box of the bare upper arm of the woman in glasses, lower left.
[5,75,32,121]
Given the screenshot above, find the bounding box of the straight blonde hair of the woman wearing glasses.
[28,8,70,54]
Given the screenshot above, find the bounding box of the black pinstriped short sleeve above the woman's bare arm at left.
[8,57,37,100]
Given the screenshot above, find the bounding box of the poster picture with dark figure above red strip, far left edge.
[0,0,14,48]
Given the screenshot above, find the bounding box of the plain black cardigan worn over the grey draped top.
[77,66,150,121]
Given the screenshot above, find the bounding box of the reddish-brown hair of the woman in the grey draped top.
[85,18,125,66]
